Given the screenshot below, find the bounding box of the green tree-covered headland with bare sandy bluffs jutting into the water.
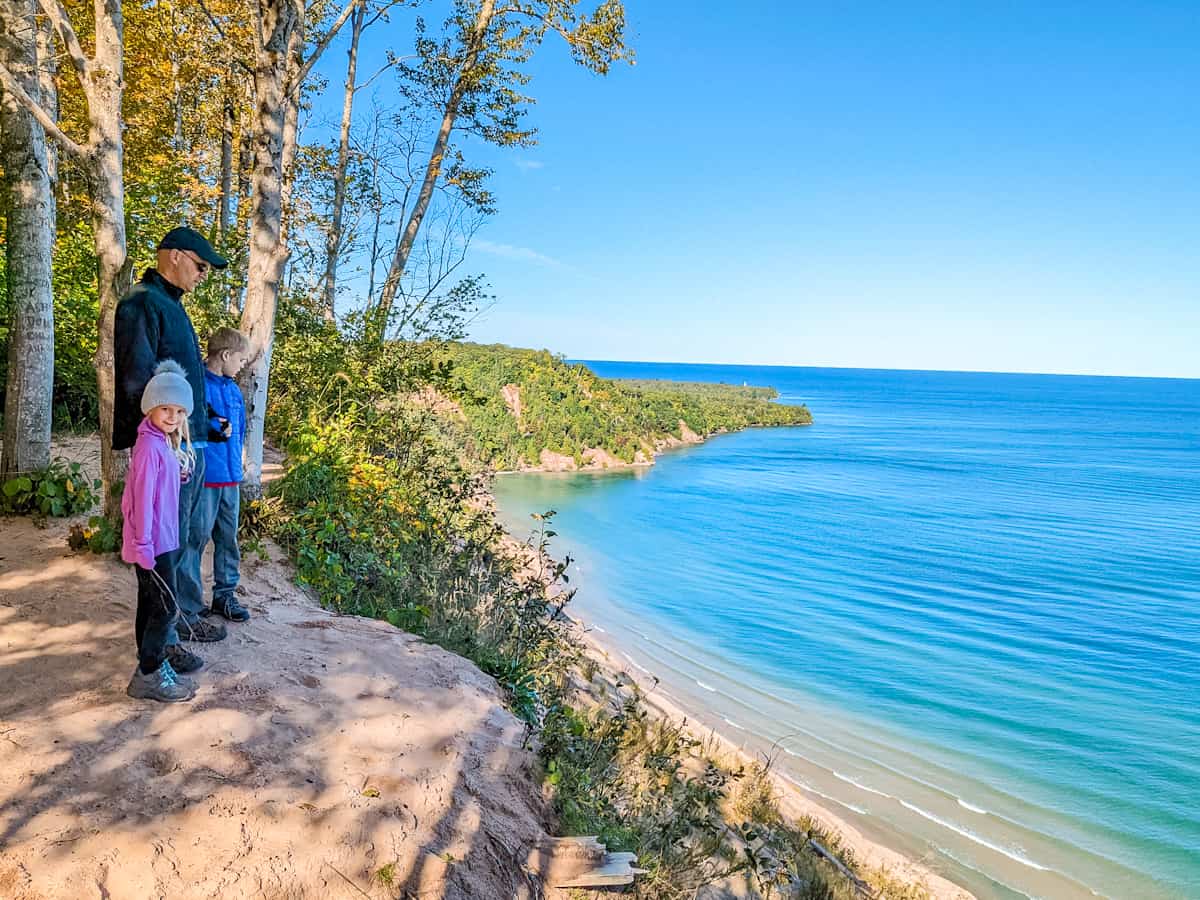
[440,343,812,469]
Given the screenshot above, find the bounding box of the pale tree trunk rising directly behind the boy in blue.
[241,0,301,497]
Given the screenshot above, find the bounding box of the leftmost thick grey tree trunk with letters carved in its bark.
[0,0,55,481]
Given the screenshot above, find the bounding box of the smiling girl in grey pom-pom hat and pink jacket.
[121,360,196,703]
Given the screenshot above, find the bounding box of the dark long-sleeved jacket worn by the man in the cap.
[113,269,209,450]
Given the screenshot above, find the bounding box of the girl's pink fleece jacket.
[121,419,180,569]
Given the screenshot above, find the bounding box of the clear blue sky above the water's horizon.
[312,0,1200,377]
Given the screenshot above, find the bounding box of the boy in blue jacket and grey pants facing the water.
[193,328,250,622]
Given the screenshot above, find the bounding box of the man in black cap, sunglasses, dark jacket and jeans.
[113,227,228,672]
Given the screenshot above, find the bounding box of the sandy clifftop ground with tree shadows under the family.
[0,518,545,900]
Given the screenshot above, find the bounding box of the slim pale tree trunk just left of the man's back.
[88,0,130,517]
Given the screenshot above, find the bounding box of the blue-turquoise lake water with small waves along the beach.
[496,362,1200,900]
